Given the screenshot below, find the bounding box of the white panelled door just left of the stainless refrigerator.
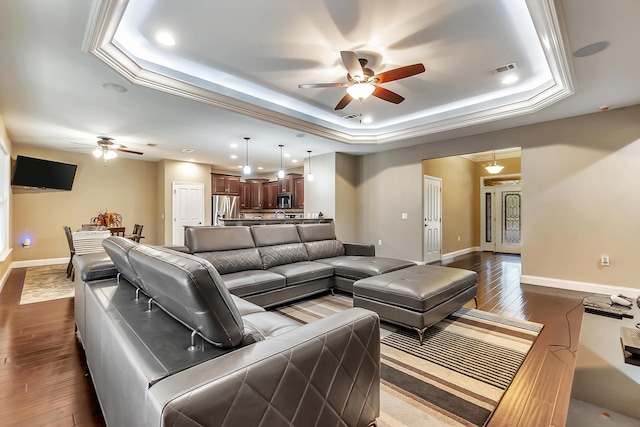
[172,182,204,245]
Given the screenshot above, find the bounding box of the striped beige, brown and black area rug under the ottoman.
[278,295,543,427]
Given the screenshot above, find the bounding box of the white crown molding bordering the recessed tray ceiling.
[83,0,574,144]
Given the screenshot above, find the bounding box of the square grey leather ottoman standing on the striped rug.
[353,265,478,344]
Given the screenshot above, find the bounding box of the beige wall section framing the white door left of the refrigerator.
[157,160,211,245]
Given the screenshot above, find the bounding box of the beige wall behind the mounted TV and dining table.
[11,144,157,261]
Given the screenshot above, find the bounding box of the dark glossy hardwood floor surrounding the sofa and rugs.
[0,252,584,427]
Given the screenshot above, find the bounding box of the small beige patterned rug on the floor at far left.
[20,264,74,305]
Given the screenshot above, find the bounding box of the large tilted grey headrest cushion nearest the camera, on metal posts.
[129,245,244,347]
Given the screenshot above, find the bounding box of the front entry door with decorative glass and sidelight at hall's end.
[480,185,522,254]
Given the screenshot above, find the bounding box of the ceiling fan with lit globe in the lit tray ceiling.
[298,50,425,110]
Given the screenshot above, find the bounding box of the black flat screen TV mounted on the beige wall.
[11,156,78,190]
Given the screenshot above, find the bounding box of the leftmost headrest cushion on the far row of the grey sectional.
[184,227,255,254]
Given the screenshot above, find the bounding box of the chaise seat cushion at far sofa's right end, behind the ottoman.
[316,256,416,280]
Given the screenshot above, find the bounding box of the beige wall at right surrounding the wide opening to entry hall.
[360,106,640,287]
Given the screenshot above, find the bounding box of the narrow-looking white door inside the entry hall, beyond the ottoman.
[423,175,442,264]
